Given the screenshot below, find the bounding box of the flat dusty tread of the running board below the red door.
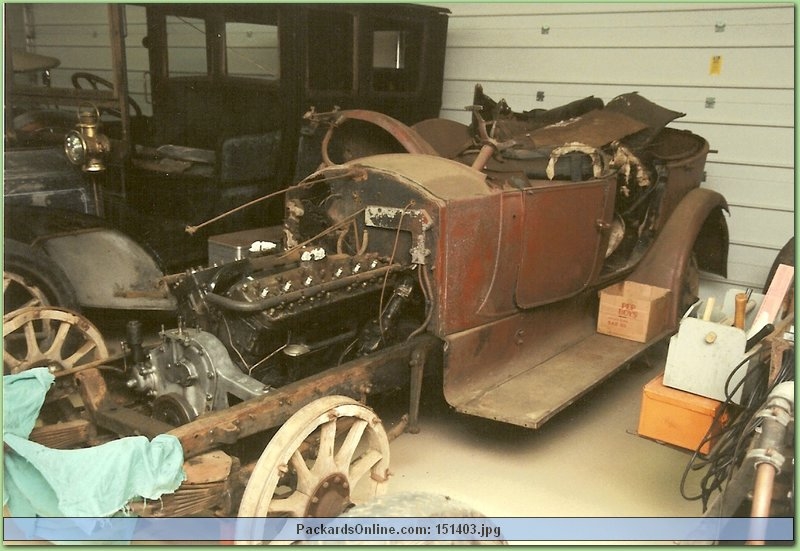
[450,333,667,429]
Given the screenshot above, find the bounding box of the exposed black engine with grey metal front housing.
[122,188,425,425]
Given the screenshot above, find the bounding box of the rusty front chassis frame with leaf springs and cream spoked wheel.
[21,329,438,517]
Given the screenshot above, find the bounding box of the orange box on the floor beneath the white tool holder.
[638,375,725,455]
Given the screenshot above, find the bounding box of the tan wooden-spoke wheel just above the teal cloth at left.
[3,307,108,374]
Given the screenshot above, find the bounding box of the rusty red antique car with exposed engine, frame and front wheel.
[4,80,728,516]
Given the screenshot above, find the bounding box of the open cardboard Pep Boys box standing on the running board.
[597,281,671,342]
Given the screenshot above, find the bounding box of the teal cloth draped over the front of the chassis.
[3,368,185,517]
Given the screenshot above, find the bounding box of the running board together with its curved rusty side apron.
[444,291,669,428]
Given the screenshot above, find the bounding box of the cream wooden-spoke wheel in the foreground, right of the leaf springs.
[239,396,389,539]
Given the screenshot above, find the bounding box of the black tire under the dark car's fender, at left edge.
[3,239,79,315]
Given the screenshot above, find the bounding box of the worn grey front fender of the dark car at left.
[34,227,176,311]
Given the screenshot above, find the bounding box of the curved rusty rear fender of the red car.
[628,188,728,327]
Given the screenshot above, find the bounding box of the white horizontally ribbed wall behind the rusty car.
[437,3,795,294]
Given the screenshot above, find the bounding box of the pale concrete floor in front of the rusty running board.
[380,354,702,517]
